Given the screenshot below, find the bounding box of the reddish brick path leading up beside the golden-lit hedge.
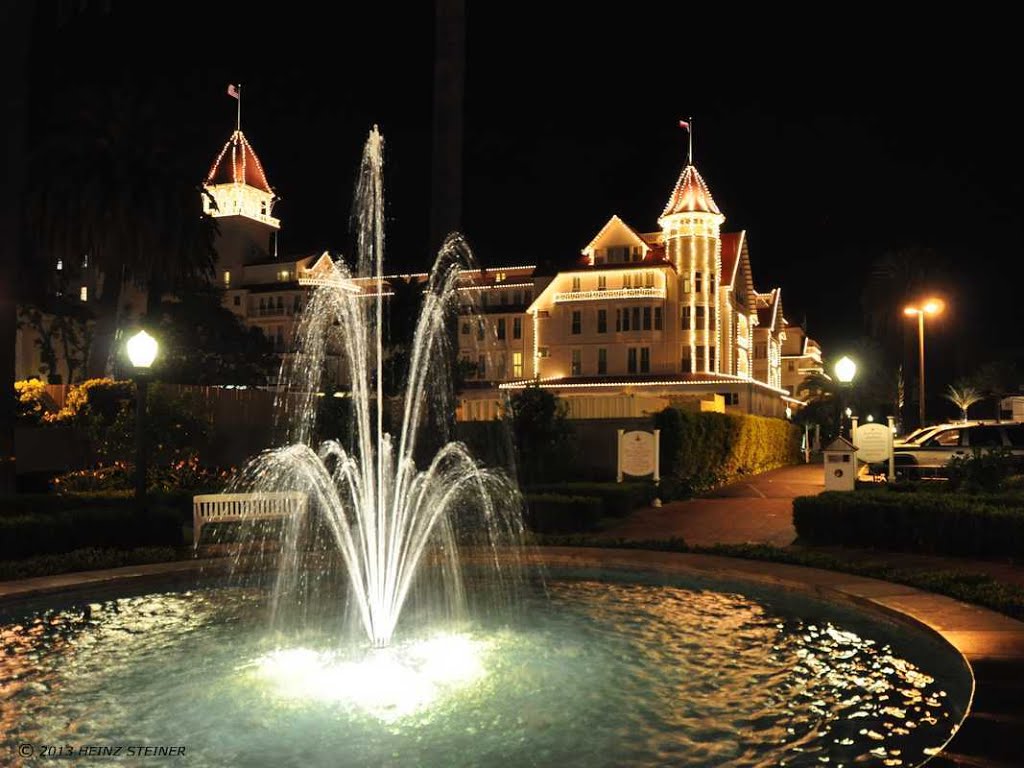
[601,464,824,547]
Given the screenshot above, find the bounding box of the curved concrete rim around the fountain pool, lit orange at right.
[0,547,1024,766]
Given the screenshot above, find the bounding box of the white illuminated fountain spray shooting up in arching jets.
[229,127,522,647]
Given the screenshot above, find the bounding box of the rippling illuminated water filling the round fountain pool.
[0,569,972,766]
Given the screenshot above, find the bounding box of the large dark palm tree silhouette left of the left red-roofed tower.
[27,78,214,375]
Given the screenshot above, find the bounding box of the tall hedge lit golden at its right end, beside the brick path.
[654,408,800,490]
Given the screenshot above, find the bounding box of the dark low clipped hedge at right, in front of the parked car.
[793,490,1024,557]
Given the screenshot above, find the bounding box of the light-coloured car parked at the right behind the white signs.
[893,422,1024,476]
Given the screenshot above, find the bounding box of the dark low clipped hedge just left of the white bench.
[0,498,182,559]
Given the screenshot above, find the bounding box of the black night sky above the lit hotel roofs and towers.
[28,0,1024,376]
